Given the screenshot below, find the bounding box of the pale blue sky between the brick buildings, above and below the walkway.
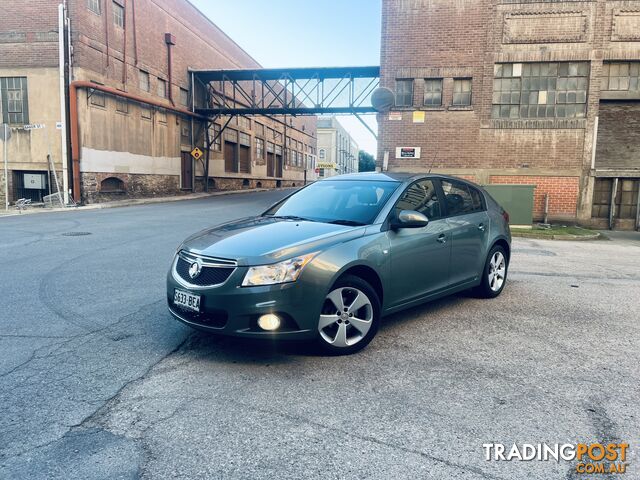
[191,0,381,156]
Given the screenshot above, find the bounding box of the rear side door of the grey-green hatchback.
[440,179,489,286]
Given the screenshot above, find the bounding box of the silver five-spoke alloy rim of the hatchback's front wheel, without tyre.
[318,287,373,348]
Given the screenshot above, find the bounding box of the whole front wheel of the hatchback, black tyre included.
[318,275,380,355]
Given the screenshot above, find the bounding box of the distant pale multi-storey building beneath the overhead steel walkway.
[316,117,360,178]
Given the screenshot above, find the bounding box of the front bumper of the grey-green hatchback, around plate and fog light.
[167,256,326,340]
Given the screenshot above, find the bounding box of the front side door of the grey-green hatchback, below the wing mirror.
[387,179,451,306]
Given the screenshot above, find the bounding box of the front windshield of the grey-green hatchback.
[265,180,399,225]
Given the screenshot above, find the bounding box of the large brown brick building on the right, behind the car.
[379,0,640,228]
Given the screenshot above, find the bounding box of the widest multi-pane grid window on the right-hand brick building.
[492,62,589,118]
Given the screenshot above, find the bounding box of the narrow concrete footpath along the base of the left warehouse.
[0,187,294,218]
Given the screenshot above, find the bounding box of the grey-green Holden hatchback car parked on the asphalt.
[167,173,511,354]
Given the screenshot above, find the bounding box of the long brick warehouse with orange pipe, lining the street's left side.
[0,0,316,202]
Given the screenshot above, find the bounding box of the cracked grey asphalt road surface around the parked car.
[0,192,640,479]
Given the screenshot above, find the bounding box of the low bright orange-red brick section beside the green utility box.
[489,175,580,219]
